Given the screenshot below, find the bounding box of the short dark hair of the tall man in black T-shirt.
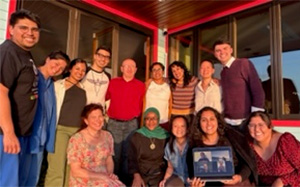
[9,9,41,28]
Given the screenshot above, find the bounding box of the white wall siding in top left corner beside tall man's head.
[0,0,9,44]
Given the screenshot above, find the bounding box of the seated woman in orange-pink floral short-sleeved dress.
[67,104,125,187]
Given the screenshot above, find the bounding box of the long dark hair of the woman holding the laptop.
[188,106,226,147]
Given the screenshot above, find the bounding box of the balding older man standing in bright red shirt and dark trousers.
[106,59,145,184]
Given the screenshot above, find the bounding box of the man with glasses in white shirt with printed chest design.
[82,46,111,107]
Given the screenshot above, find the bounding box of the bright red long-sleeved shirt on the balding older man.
[106,77,145,120]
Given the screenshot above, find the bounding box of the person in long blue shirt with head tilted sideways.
[27,51,70,187]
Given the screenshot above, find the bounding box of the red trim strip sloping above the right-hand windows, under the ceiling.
[169,0,272,34]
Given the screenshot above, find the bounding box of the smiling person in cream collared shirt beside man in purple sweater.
[195,60,222,113]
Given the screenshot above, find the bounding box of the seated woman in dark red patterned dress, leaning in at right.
[247,112,300,187]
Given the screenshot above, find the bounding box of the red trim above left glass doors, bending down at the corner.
[82,0,158,61]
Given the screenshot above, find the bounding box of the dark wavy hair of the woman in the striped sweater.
[168,61,192,89]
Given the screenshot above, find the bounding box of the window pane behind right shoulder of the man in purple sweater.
[236,6,273,113]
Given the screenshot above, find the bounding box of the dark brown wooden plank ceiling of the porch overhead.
[97,0,253,29]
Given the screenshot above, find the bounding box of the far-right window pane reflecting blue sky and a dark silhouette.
[281,1,300,114]
